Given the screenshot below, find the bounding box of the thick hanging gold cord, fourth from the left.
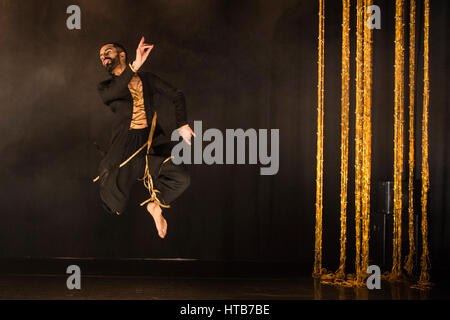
[357,0,372,281]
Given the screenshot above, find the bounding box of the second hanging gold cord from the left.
[336,0,350,279]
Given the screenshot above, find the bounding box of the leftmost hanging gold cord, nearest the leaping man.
[313,0,325,277]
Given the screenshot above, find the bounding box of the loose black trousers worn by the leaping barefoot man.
[117,127,190,212]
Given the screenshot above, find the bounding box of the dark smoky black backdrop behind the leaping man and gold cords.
[0,0,450,278]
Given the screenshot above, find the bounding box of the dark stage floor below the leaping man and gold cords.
[0,275,450,300]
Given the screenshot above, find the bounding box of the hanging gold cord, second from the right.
[405,0,416,277]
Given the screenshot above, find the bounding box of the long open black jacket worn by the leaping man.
[97,65,187,212]
